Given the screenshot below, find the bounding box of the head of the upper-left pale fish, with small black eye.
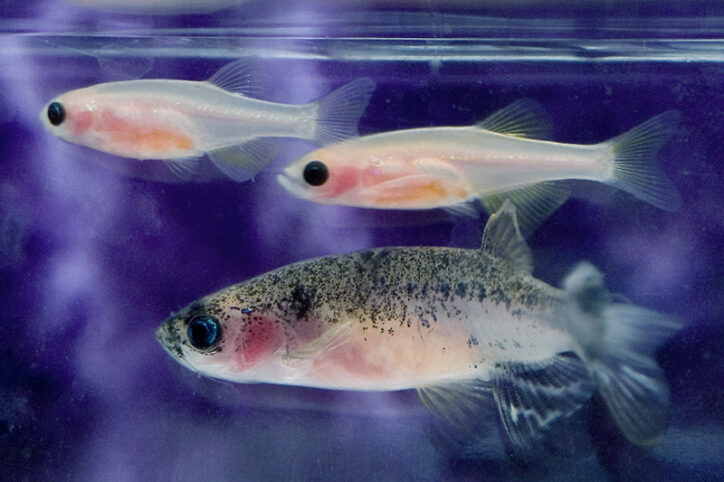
[40,89,97,147]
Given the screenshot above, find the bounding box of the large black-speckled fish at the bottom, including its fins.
[156,200,681,453]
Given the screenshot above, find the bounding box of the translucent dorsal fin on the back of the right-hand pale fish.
[476,99,553,139]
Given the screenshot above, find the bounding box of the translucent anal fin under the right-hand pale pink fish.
[480,182,571,237]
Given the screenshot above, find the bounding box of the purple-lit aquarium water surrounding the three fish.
[0,2,724,480]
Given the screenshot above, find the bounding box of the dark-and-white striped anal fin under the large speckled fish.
[492,355,595,451]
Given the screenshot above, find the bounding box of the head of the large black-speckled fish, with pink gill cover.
[156,287,285,382]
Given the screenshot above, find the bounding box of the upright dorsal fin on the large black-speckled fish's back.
[481,200,533,273]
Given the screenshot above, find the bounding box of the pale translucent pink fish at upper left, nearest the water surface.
[40,58,375,182]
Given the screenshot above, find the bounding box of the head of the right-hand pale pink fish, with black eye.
[277,144,368,206]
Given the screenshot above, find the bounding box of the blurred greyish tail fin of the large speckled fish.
[564,263,680,445]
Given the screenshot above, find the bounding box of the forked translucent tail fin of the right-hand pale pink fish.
[605,110,681,211]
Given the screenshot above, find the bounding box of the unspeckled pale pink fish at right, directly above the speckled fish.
[277,98,681,235]
